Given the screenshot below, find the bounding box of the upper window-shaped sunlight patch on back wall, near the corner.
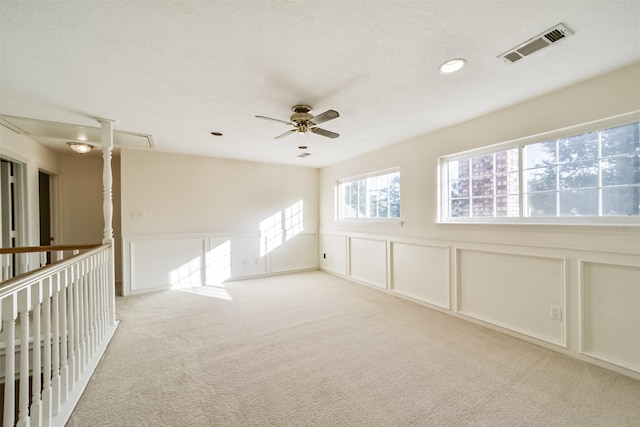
[260,199,304,257]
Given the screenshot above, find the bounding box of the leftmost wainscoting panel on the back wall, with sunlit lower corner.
[130,239,205,292]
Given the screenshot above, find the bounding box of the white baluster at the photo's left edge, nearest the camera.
[2,294,18,426]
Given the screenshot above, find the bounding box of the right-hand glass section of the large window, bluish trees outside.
[523,123,640,216]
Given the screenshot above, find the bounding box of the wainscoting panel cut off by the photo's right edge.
[581,262,640,372]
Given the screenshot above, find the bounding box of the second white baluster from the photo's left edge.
[17,288,31,427]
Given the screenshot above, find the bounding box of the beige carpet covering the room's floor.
[68,271,640,427]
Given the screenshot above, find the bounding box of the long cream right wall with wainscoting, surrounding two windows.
[319,64,640,378]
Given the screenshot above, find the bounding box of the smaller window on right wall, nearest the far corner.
[338,169,400,220]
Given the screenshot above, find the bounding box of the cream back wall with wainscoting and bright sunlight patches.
[121,150,318,294]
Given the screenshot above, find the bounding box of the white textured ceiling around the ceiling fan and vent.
[0,0,640,167]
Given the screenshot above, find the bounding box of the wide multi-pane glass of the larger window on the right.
[441,118,640,222]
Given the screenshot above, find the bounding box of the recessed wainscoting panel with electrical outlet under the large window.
[457,249,566,346]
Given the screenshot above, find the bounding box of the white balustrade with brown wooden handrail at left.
[0,244,117,427]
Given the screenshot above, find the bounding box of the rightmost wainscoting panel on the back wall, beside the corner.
[271,234,318,273]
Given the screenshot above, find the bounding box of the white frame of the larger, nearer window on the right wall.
[437,110,640,226]
